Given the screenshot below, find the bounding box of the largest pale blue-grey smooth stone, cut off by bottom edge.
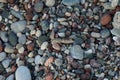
[15,66,32,80]
